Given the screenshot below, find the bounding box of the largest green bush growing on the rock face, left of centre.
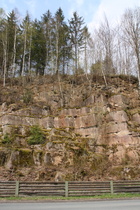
[27,125,46,145]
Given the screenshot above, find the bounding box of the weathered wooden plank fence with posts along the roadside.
[0,181,140,197]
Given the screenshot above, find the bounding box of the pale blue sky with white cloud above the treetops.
[0,0,140,32]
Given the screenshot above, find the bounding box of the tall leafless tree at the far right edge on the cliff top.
[122,7,140,89]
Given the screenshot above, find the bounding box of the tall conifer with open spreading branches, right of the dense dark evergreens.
[69,12,84,74]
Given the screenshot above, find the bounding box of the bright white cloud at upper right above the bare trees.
[88,0,140,32]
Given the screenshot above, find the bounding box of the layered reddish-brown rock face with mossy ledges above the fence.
[0,76,140,181]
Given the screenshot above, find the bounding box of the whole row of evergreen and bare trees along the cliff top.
[0,7,140,89]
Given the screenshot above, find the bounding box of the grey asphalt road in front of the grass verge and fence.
[0,200,140,210]
